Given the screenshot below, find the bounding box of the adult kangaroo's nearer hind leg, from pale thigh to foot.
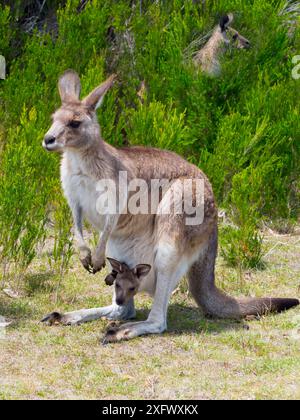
[104,180,199,343]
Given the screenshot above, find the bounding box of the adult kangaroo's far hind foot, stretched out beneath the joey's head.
[41,301,136,325]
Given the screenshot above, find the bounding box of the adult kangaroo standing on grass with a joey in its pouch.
[43,70,299,341]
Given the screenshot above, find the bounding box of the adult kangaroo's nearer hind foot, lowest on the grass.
[102,320,167,345]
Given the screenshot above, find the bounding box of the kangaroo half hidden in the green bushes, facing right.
[194,14,251,77]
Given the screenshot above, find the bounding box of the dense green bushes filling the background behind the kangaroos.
[0,0,300,271]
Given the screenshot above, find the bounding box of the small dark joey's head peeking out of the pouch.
[105,258,151,306]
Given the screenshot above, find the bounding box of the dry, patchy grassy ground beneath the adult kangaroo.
[0,230,300,399]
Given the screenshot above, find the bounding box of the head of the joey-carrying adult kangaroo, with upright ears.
[43,70,115,152]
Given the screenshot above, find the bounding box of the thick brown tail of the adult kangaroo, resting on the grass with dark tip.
[188,228,300,319]
